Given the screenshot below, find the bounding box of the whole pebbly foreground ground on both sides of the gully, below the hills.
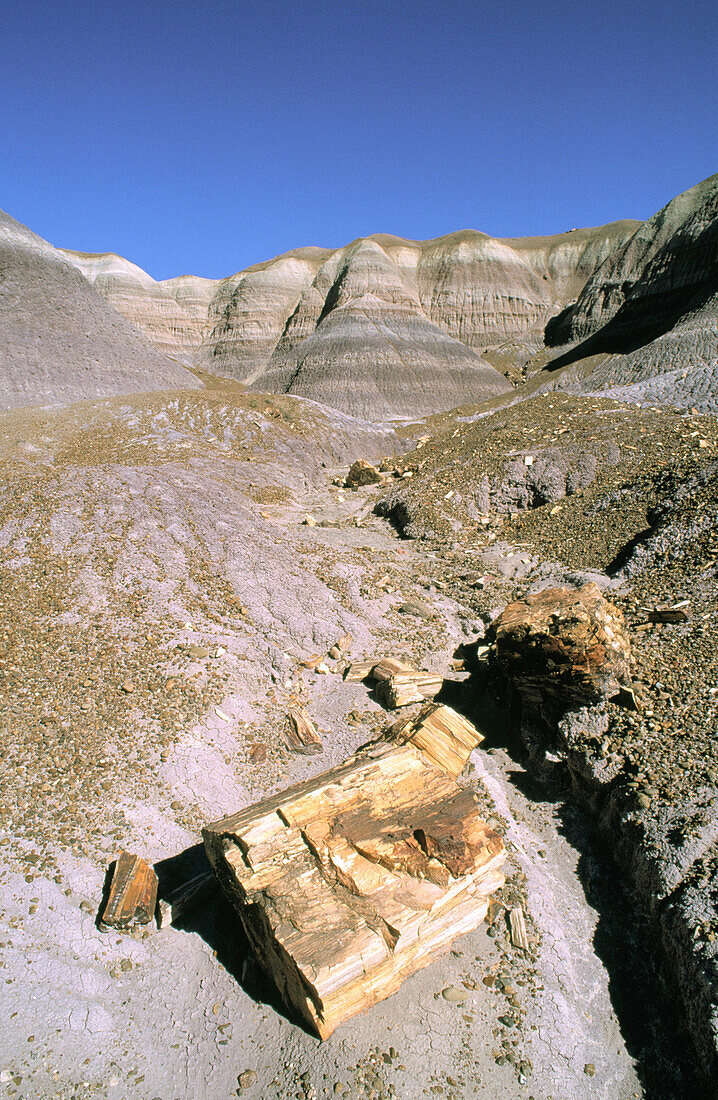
[0,382,718,1100]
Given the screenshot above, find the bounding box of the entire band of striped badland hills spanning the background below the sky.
[11,175,718,420]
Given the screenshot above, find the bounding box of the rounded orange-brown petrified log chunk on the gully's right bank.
[487,584,631,707]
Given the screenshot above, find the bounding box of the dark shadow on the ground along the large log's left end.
[155,844,319,1042]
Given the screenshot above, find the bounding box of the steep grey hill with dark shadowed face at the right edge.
[545,175,718,411]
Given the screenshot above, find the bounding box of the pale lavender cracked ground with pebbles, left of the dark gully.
[0,383,703,1100]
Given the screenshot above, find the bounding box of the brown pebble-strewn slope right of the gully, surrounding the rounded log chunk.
[369,394,718,1079]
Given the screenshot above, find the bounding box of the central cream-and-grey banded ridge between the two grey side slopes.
[58,222,638,419]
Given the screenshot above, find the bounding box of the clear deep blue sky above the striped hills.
[0,0,718,278]
